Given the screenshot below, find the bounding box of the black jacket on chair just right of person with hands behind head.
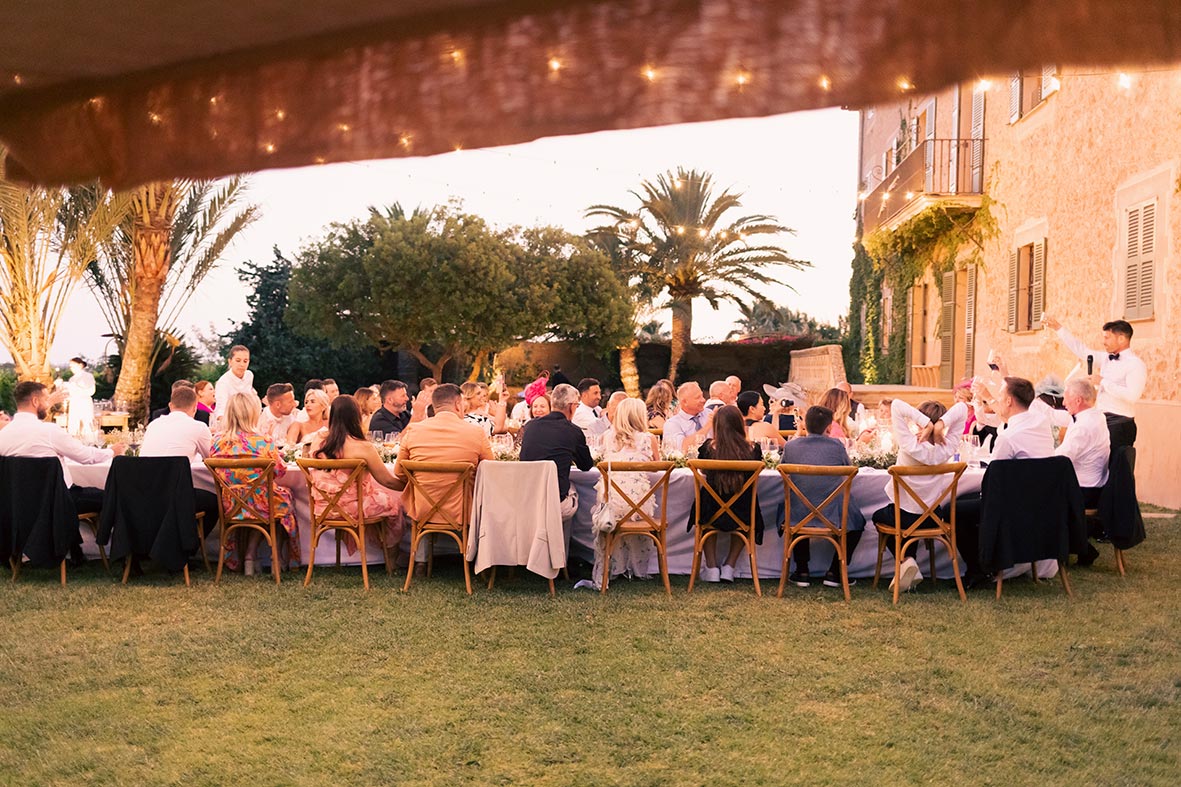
[980,456,1087,572]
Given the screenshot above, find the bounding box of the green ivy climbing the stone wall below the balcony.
[844,195,997,385]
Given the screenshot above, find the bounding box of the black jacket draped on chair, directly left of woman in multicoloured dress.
[98,456,200,571]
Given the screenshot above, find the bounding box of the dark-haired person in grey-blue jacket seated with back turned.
[781,406,866,587]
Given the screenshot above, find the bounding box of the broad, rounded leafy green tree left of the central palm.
[288,206,618,379]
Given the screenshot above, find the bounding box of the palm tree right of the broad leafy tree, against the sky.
[586,168,809,381]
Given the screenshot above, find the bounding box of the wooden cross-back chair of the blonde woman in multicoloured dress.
[205,457,280,585]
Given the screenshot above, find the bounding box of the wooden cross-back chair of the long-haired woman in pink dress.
[295,457,393,590]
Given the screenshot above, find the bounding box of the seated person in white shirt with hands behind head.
[873,399,963,591]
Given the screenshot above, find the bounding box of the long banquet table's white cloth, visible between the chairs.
[70,462,987,579]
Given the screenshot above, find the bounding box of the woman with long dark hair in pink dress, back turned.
[308,389,403,554]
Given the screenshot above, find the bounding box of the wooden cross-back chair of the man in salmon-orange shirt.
[398,460,476,596]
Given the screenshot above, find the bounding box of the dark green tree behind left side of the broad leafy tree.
[223,248,397,394]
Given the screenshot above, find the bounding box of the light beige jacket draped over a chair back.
[468,462,566,579]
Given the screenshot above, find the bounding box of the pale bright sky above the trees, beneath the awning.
[11,109,857,373]
